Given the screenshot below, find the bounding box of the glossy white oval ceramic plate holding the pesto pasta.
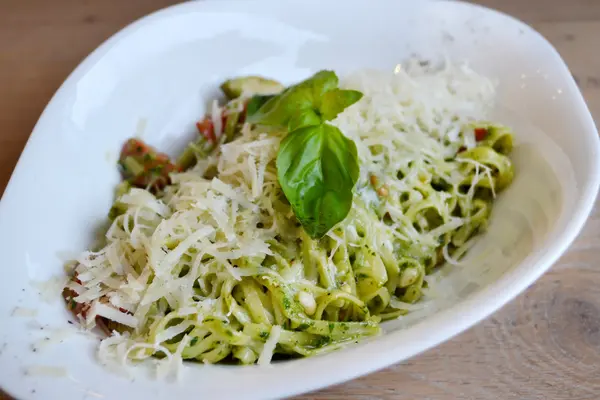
[0,0,600,400]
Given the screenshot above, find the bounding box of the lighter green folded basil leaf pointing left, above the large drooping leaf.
[248,71,338,126]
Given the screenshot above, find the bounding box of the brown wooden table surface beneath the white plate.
[0,0,600,400]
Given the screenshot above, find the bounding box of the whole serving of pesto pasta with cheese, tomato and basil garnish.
[63,61,513,372]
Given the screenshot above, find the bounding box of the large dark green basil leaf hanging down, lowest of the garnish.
[277,124,359,238]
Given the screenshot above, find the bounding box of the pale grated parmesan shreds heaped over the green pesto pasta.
[68,62,506,377]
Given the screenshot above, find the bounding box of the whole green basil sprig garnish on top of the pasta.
[248,71,362,239]
